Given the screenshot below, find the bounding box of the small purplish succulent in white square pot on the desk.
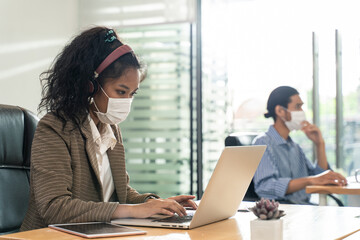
[249,198,285,240]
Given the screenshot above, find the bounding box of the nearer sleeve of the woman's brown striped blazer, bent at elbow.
[31,117,118,225]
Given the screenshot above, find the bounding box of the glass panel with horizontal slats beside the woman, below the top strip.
[119,24,191,197]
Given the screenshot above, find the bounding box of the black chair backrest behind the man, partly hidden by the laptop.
[225,132,260,201]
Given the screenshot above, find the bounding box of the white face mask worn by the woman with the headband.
[94,86,132,124]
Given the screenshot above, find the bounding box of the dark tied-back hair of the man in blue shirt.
[264,86,299,121]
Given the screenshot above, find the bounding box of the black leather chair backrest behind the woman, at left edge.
[0,104,39,235]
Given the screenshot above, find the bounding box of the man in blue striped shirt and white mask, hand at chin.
[253,86,347,204]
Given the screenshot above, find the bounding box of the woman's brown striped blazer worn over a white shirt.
[21,113,156,231]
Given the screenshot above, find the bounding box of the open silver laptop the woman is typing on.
[111,145,266,229]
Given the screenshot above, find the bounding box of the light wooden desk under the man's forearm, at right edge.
[305,182,360,207]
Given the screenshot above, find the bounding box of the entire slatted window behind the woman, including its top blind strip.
[79,0,196,197]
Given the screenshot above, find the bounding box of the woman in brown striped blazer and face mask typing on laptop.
[21,27,196,230]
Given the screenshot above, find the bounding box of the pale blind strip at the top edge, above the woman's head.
[79,0,196,27]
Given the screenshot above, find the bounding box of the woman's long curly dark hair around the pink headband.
[38,27,145,127]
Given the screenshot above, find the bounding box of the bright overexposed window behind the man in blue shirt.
[203,0,360,206]
